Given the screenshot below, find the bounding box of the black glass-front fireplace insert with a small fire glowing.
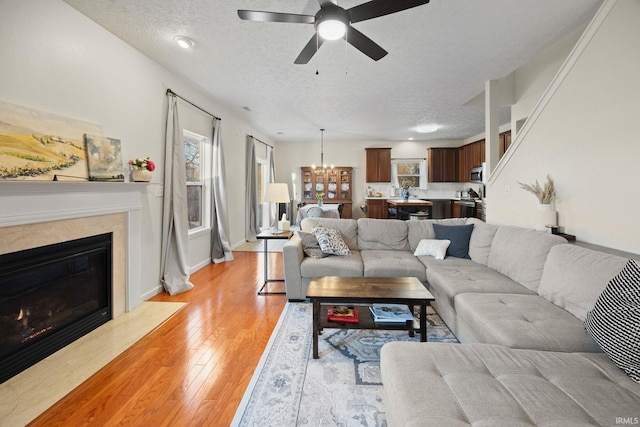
[0,233,112,383]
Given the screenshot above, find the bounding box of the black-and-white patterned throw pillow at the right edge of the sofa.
[584,260,640,383]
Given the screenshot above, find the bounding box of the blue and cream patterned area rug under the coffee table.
[232,303,458,426]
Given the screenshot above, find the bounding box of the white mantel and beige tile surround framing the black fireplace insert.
[0,181,146,318]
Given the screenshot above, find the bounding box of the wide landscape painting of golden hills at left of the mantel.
[0,102,102,181]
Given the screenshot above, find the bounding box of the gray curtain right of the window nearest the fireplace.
[211,118,233,263]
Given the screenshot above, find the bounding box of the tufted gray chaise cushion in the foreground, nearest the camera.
[380,342,640,427]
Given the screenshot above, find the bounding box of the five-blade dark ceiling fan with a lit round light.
[238,0,430,64]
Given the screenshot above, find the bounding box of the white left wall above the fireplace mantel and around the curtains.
[0,0,270,299]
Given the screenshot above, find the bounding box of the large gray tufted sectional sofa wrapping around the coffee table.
[284,218,640,426]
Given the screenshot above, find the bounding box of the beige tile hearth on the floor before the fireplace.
[0,301,186,427]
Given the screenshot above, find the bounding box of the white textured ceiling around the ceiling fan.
[65,0,602,142]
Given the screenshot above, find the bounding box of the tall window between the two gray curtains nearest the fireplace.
[183,130,211,234]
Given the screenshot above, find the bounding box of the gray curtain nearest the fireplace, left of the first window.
[160,94,193,295]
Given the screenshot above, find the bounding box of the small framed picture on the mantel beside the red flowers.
[84,134,124,182]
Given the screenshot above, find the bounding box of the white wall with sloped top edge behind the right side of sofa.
[488,0,640,253]
